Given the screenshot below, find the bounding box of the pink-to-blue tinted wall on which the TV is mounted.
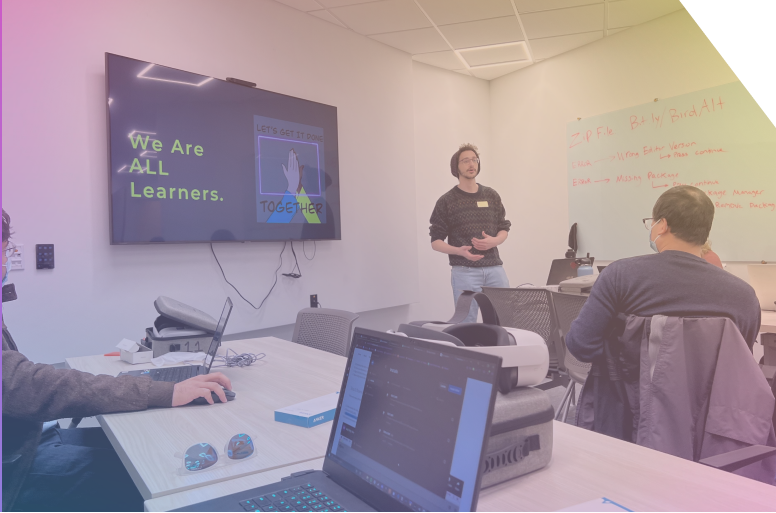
[2,0,430,362]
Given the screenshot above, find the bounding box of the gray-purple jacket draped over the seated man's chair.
[612,316,776,462]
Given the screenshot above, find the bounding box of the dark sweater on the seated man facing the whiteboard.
[566,251,761,362]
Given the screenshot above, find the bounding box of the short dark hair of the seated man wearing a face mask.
[652,185,714,246]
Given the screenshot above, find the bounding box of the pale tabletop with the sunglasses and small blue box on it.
[67,338,347,499]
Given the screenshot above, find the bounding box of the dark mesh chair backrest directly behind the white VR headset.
[482,287,563,369]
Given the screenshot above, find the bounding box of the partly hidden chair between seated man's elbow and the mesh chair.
[551,292,591,422]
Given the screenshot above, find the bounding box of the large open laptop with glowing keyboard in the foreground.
[176,328,501,511]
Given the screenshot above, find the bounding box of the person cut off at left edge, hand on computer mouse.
[2,210,232,511]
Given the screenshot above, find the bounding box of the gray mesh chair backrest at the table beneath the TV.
[291,308,358,356]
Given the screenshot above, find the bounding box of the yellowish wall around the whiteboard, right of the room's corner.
[490,10,746,285]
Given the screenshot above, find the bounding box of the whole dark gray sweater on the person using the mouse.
[3,323,175,511]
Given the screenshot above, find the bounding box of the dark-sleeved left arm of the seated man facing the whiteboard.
[565,269,617,362]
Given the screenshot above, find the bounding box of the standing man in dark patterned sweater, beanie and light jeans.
[430,144,512,322]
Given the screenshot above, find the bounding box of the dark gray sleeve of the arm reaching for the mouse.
[3,350,175,422]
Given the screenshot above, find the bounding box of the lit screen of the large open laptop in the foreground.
[327,328,501,511]
